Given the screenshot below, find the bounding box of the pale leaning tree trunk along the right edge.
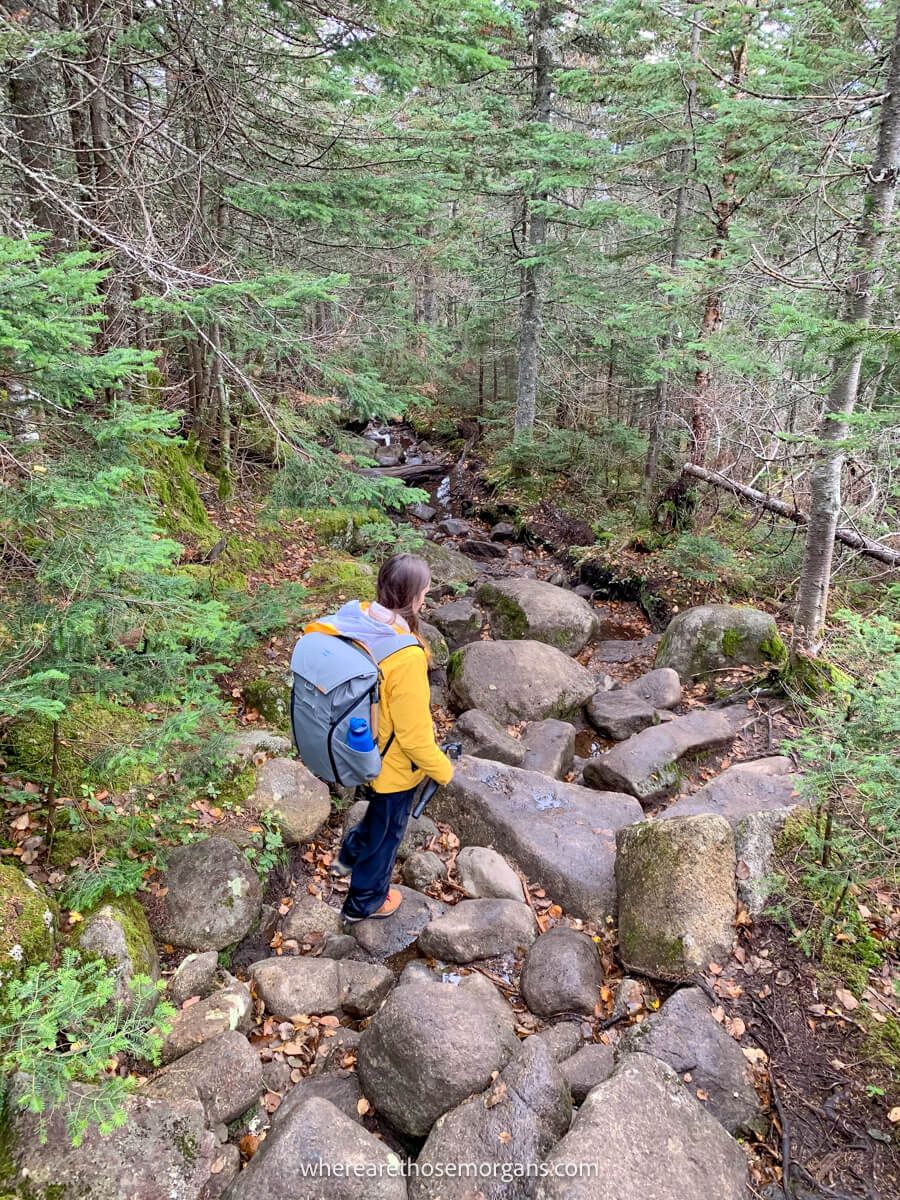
[793,12,900,652]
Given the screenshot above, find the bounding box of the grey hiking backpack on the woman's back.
[290,632,421,787]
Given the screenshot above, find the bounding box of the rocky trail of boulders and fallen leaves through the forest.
[7,429,889,1200]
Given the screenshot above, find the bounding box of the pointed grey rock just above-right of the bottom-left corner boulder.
[143,1030,263,1126]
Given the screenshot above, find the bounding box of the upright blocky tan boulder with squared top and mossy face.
[616,816,737,982]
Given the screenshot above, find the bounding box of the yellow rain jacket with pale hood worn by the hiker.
[304,600,454,792]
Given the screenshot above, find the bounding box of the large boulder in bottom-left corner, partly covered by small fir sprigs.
[0,1075,220,1200]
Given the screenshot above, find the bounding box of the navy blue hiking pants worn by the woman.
[341,787,415,917]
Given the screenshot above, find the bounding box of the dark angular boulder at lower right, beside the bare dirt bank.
[617,988,760,1133]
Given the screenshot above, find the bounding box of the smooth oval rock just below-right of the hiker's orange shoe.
[419,900,538,962]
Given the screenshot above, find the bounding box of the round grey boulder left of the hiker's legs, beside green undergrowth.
[150,838,262,950]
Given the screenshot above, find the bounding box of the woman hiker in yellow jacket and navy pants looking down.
[300,554,454,924]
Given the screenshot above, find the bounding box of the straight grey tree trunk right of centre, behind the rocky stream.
[515,0,556,439]
